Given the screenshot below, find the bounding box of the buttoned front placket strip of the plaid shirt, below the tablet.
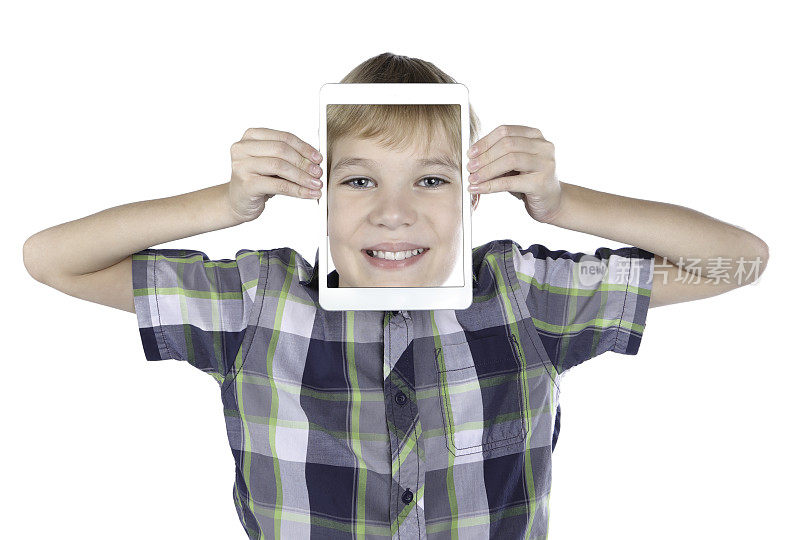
[383,311,426,539]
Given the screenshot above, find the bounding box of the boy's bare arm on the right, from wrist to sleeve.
[546,182,769,308]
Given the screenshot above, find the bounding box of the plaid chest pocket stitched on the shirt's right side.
[436,333,527,456]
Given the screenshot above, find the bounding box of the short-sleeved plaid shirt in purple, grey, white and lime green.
[133,240,654,539]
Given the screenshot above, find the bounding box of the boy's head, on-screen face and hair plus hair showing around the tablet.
[327,53,479,287]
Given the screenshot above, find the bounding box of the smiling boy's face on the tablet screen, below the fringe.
[328,127,477,287]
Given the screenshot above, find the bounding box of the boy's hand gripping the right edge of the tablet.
[467,125,561,223]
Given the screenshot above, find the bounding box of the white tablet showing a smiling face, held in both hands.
[318,83,472,311]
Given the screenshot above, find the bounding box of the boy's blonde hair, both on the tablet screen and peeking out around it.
[327,52,480,175]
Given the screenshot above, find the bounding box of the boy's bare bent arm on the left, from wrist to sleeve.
[23,182,242,313]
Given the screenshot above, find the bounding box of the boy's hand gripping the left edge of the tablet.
[228,128,322,221]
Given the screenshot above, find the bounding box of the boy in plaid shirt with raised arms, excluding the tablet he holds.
[20,53,768,539]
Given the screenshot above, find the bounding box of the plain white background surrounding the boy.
[0,0,800,540]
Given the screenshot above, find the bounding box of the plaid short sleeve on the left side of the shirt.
[132,249,261,384]
